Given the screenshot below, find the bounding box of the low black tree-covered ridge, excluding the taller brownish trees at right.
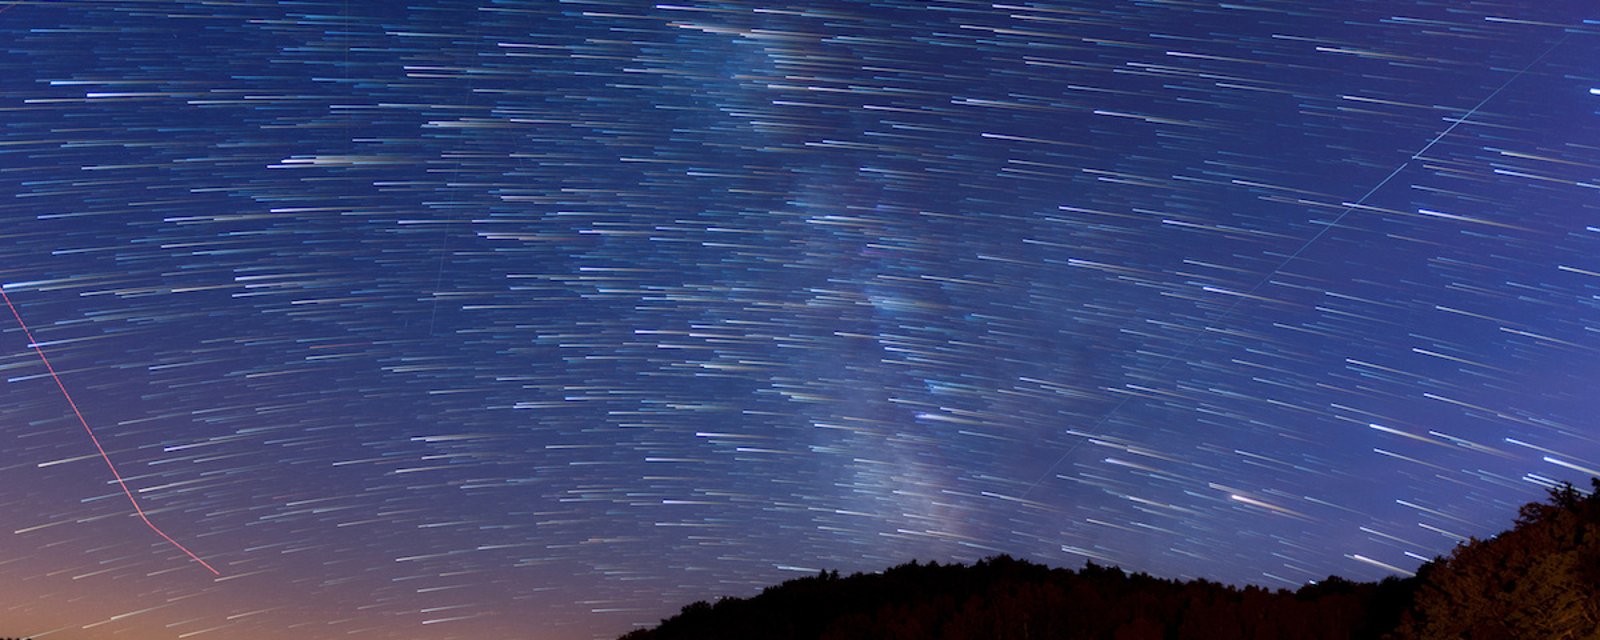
[624,555,1408,640]
